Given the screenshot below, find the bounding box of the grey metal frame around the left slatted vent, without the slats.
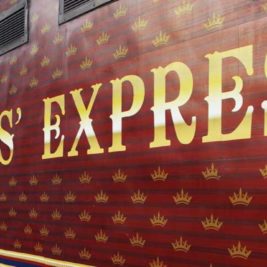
[0,0,30,56]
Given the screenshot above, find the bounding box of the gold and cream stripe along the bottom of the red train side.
[0,249,93,267]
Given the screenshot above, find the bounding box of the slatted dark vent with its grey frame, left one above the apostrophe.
[0,0,29,55]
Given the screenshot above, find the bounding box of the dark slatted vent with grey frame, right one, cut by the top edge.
[59,0,114,24]
